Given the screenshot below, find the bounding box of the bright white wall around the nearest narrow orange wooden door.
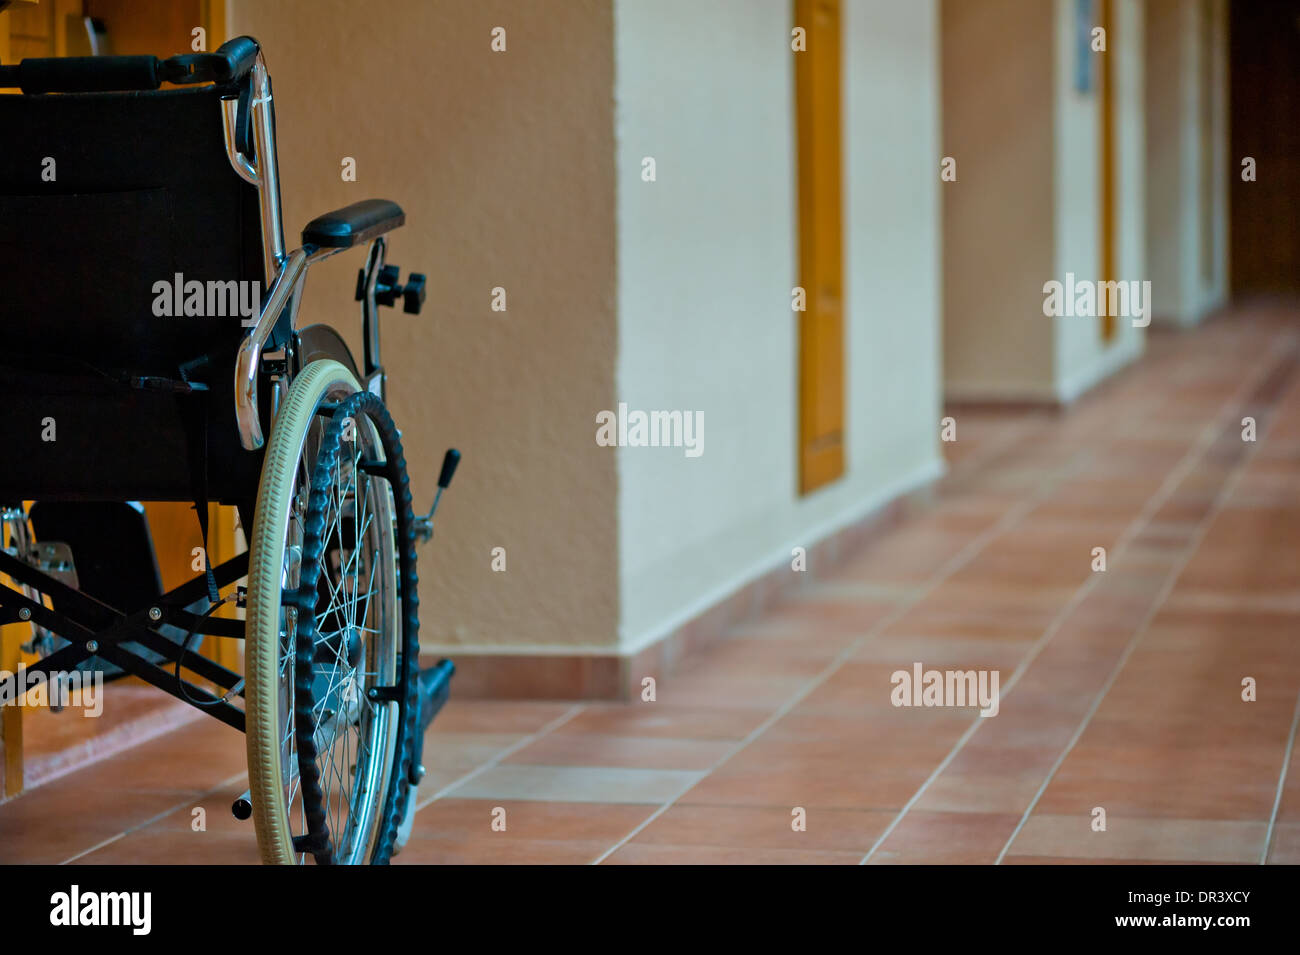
[615,0,941,652]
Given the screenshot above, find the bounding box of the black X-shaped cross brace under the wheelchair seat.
[0,551,248,733]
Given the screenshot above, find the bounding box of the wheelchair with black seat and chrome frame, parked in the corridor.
[0,36,459,864]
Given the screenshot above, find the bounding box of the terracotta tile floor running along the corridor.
[0,311,1300,864]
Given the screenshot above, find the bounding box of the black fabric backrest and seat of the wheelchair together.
[0,86,265,503]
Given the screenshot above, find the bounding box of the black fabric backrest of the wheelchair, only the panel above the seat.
[0,86,263,377]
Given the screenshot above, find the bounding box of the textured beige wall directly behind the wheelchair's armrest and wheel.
[229,0,619,651]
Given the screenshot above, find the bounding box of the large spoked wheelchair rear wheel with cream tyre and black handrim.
[246,360,419,864]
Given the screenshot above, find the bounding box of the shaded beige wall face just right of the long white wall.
[936,0,1058,401]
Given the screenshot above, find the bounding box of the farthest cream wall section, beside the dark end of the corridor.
[1145,0,1238,325]
